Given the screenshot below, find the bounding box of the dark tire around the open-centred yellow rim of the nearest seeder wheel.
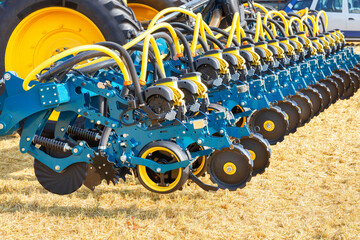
[136,141,190,194]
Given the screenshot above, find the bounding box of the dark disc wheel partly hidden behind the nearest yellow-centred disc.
[240,134,271,176]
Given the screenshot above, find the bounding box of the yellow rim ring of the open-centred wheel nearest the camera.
[138,147,182,192]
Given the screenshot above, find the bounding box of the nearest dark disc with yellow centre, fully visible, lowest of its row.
[208,145,253,191]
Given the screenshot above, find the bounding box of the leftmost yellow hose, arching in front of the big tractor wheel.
[23,45,131,91]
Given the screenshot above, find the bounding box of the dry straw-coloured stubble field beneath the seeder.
[0,62,360,239]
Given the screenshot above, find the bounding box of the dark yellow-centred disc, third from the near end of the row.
[249,107,289,145]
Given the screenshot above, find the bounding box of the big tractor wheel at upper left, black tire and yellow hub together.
[0,0,142,78]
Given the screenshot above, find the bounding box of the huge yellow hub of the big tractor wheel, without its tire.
[5,7,105,78]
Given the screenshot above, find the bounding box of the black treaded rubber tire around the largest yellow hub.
[0,0,142,75]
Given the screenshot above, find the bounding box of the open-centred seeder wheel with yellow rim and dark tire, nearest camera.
[136,141,190,194]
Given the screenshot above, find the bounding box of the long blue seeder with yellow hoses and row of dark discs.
[0,1,360,194]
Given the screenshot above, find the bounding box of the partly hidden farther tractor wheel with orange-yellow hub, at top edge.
[127,0,188,23]
